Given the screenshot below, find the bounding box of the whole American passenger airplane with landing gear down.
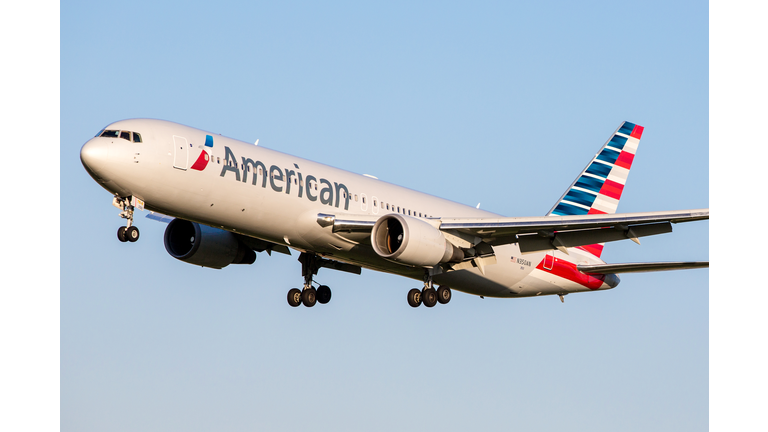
[80,119,709,307]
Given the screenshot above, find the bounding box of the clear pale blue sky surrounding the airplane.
[1,2,732,431]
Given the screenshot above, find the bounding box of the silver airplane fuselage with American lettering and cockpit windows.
[81,119,618,297]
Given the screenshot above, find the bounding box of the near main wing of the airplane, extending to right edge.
[317,209,709,253]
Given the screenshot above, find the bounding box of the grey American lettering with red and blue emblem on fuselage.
[218,145,350,210]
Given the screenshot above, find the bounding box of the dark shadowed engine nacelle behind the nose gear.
[163,219,256,269]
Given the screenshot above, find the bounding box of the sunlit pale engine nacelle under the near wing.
[371,214,464,267]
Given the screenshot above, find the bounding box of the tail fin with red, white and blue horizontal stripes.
[547,122,643,257]
